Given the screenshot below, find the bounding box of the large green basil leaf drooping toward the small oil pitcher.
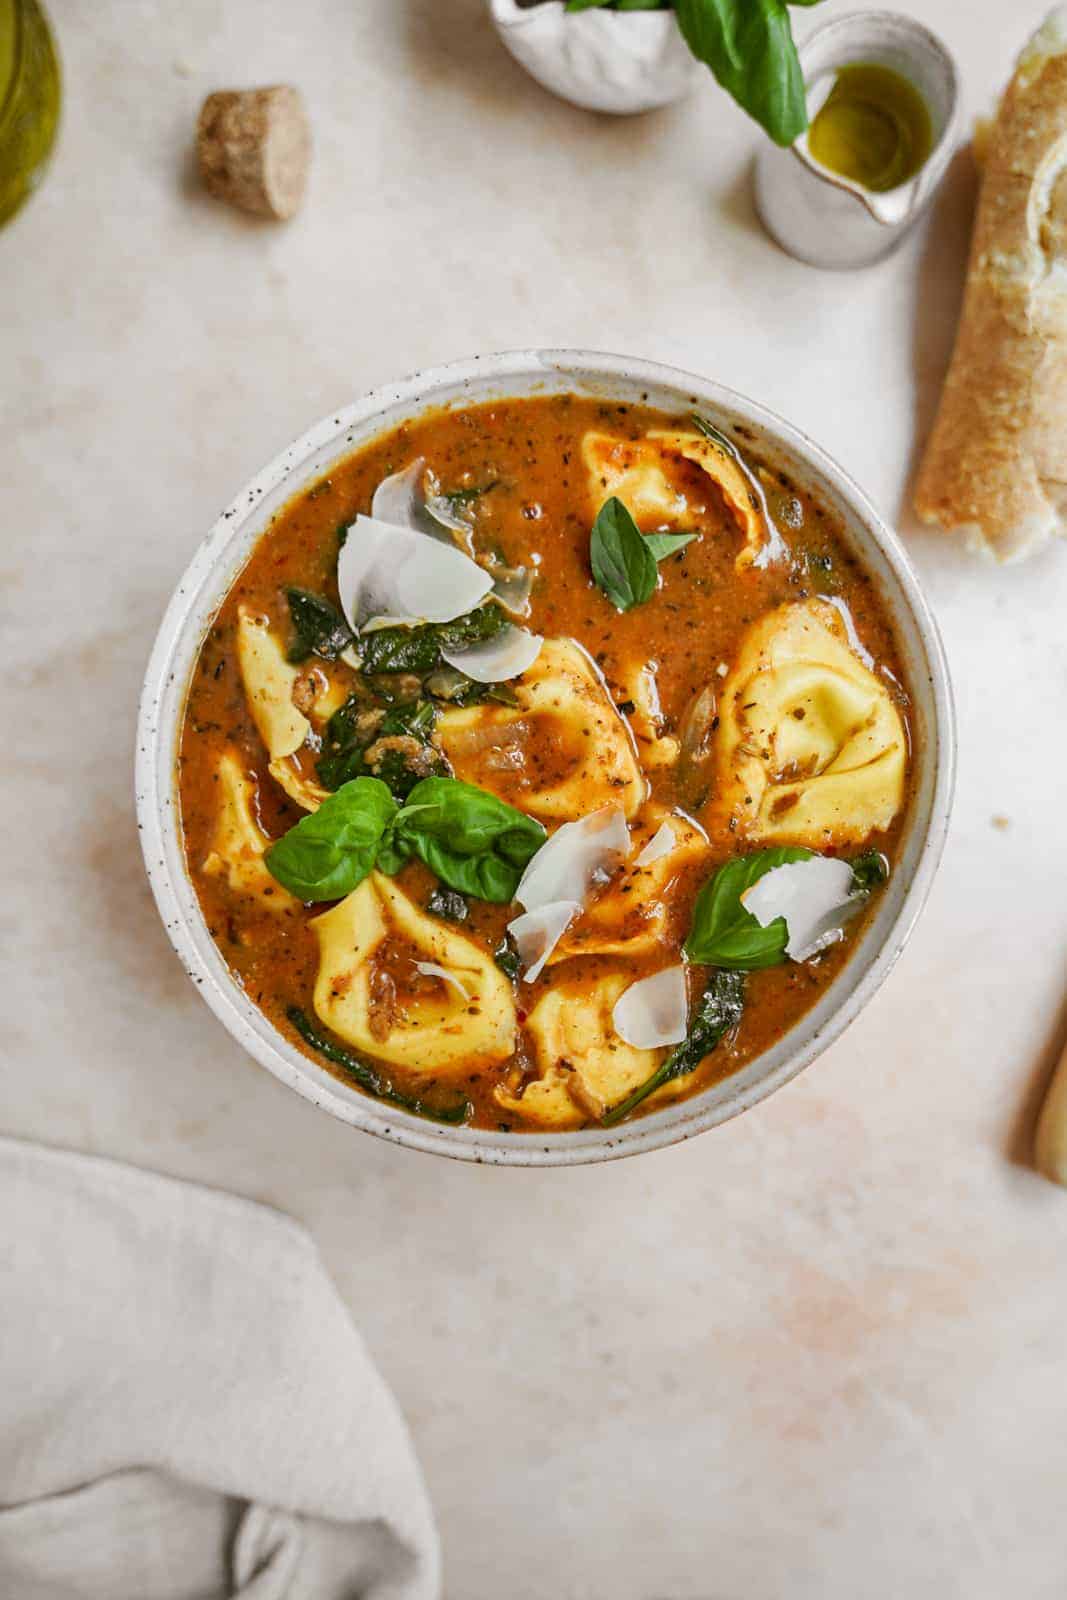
[673,0,817,144]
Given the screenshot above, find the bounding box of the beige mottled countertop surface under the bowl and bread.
[8,0,1067,1600]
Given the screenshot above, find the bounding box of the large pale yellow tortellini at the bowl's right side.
[709,600,907,850]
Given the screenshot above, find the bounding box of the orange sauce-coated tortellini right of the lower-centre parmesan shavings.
[547,806,707,966]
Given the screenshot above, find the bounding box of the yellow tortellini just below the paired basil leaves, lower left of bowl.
[310,872,518,1075]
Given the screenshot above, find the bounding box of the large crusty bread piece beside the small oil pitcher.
[915,5,1067,560]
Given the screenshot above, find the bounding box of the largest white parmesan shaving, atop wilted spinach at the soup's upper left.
[338,517,493,632]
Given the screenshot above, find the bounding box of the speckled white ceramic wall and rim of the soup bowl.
[136,350,955,1166]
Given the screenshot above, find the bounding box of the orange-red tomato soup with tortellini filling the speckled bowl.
[179,395,910,1133]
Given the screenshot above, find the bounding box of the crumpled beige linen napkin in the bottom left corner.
[0,1138,440,1600]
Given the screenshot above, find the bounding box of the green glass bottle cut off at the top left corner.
[0,0,59,224]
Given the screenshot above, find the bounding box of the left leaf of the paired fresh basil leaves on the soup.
[264,778,397,901]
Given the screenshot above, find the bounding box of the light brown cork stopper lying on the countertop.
[197,83,312,221]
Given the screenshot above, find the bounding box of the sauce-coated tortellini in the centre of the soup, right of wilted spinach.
[437,638,646,824]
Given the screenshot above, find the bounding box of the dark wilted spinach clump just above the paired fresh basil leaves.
[317,694,451,800]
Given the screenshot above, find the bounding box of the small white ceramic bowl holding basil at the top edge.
[490,0,704,115]
